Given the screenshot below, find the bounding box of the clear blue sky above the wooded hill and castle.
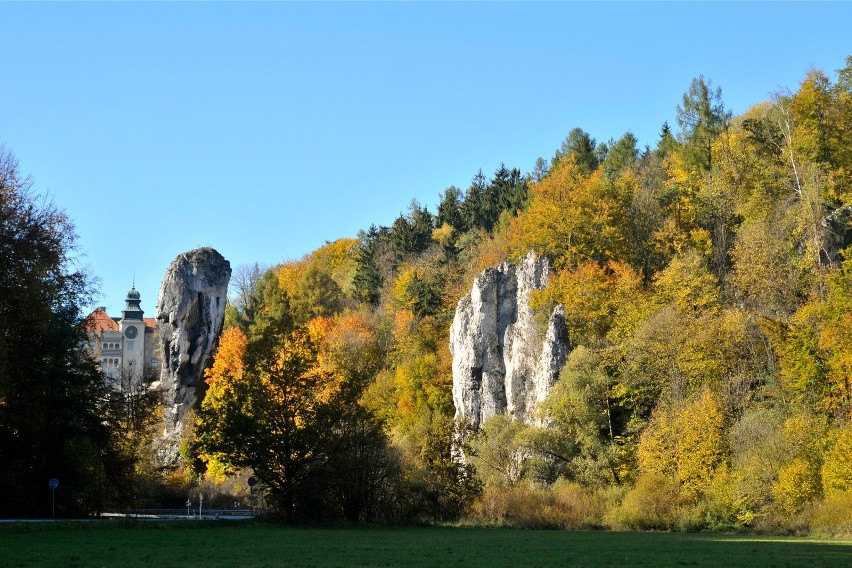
[0,2,852,316]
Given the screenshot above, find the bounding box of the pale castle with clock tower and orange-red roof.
[87,286,160,386]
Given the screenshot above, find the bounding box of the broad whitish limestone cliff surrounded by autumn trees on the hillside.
[450,253,568,430]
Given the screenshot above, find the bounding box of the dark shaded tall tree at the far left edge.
[0,146,111,517]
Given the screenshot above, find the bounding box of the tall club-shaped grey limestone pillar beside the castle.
[157,248,231,463]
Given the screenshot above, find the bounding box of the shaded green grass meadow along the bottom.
[0,521,852,568]
